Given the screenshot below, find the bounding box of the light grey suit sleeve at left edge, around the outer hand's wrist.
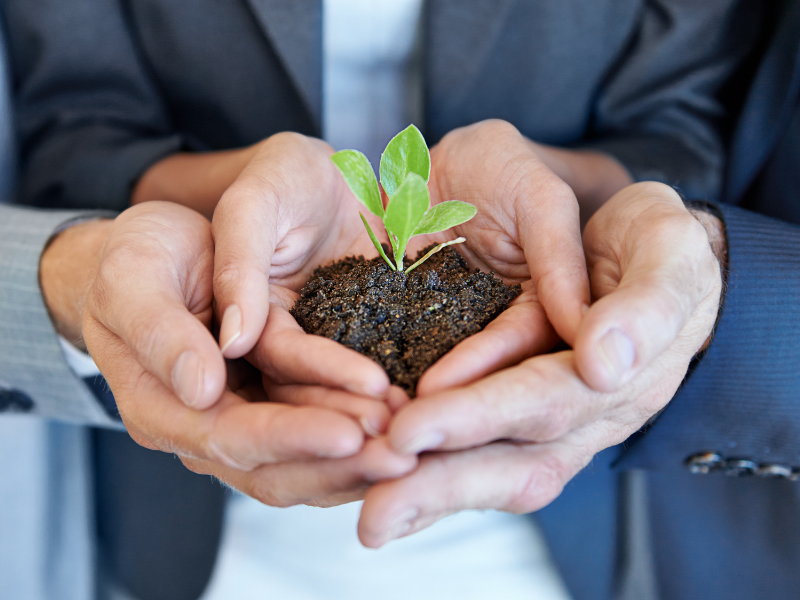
[0,204,119,428]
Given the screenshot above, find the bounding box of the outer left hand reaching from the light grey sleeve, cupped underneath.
[68,202,416,505]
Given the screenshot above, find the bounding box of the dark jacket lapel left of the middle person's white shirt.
[247,0,322,128]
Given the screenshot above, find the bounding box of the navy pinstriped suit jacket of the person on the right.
[538,0,800,600]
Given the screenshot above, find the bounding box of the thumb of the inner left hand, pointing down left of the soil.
[212,174,279,358]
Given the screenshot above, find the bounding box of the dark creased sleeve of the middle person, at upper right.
[583,0,763,199]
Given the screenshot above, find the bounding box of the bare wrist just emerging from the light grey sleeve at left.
[39,219,113,350]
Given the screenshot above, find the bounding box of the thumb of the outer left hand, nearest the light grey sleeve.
[84,246,226,409]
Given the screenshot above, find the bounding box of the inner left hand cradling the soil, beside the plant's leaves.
[213,133,416,410]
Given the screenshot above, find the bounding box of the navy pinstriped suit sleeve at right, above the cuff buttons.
[619,205,800,470]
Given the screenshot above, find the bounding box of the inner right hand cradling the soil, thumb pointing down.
[417,120,589,395]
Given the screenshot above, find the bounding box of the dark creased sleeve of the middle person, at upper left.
[0,0,182,210]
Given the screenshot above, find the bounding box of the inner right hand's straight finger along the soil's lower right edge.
[417,292,556,397]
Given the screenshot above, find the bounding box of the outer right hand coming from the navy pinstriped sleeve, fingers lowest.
[359,183,721,547]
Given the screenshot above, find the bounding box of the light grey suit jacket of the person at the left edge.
[0,50,111,600]
